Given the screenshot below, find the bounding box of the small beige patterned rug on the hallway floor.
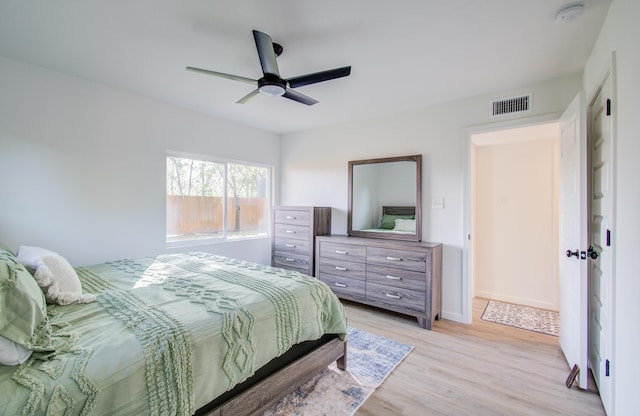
[482,300,560,336]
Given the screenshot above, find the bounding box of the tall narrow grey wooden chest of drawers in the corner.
[271,206,331,276]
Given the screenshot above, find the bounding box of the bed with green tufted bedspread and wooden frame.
[0,247,346,416]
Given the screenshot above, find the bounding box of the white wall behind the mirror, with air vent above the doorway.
[280,75,581,321]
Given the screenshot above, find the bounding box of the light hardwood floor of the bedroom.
[345,299,605,416]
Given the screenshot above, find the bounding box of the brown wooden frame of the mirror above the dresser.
[347,155,422,241]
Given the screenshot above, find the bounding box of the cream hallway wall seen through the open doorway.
[472,135,559,310]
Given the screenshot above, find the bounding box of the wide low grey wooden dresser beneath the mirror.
[316,235,442,329]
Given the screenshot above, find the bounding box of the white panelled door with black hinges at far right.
[588,66,614,414]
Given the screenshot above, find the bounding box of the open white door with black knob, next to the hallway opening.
[558,91,588,389]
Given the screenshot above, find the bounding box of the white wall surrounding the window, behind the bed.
[0,58,279,265]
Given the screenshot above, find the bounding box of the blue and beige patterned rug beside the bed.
[264,327,413,416]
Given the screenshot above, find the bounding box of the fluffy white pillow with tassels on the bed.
[18,246,96,305]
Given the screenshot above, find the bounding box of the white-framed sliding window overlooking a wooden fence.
[167,154,271,245]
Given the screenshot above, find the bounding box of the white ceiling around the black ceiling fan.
[0,0,610,133]
